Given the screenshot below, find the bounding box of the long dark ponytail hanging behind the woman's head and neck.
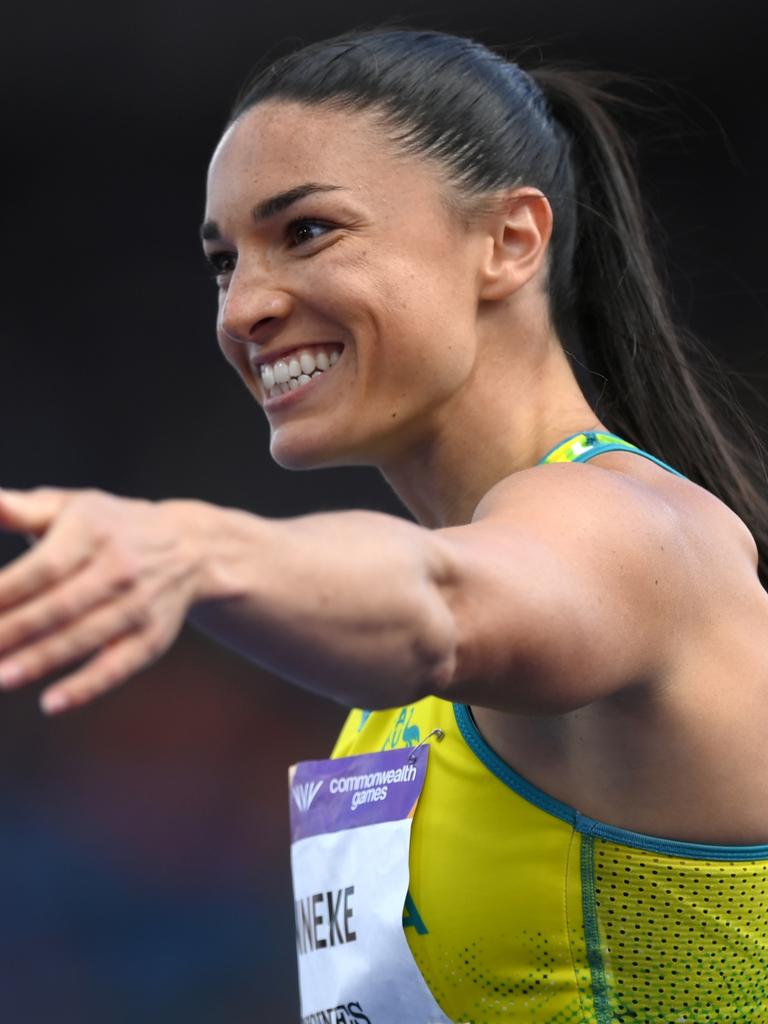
[529,68,768,587]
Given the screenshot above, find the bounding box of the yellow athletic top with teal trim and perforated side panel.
[332,433,768,1024]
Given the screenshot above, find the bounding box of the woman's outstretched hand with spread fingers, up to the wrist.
[0,487,204,713]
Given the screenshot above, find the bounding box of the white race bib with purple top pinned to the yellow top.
[289,744,451,1024]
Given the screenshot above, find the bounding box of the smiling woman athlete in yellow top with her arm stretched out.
[0,31,768,1024]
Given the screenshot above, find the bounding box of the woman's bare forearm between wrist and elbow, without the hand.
[173,501,462,708]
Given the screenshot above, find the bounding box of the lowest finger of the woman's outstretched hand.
[40,633,173,715]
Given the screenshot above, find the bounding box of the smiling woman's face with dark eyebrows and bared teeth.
[203,100,483,468]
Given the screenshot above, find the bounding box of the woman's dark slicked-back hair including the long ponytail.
[230,29,768,583]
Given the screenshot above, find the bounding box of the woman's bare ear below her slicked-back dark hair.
[479,187,552,301]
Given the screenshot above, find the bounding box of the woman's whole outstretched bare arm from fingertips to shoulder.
[0,466,695,713]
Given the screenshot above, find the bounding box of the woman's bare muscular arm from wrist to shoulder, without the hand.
[179,466,687,713]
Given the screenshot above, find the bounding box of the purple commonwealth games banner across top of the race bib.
[290,744,429,843]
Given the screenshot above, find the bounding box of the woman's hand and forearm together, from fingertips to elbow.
[0,488,453,712]
